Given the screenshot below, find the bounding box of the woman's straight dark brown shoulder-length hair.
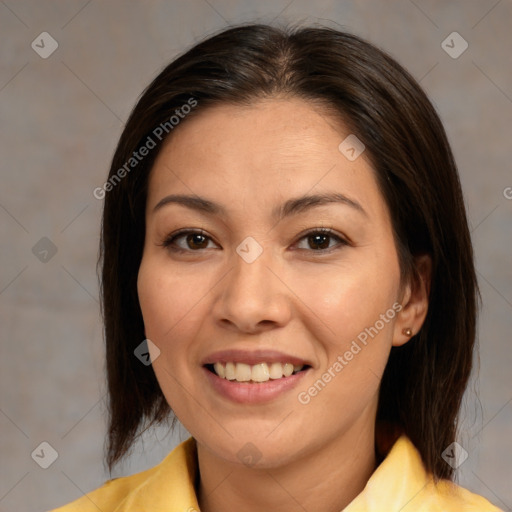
[98,25,478,479]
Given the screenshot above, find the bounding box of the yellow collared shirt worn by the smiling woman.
[52,435,503,512]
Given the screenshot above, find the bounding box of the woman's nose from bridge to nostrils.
[212,245,292,333]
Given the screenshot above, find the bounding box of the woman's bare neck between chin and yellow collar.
[198,422,376,512]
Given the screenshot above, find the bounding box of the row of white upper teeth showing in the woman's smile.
[209,362,304,382]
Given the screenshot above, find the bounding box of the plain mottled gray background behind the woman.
[0,0,512,512]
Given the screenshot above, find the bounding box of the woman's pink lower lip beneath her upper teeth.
[203,367,309,404]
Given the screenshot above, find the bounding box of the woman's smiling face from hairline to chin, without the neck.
[138,99,412,467]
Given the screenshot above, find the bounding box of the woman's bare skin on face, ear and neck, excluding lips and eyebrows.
[138,98,429,512]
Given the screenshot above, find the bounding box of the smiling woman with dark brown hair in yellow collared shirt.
[53,25,504,512]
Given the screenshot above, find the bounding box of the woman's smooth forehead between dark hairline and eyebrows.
[148,99,383,221]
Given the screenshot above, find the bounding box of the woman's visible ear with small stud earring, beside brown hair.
[393,254,432,347]
